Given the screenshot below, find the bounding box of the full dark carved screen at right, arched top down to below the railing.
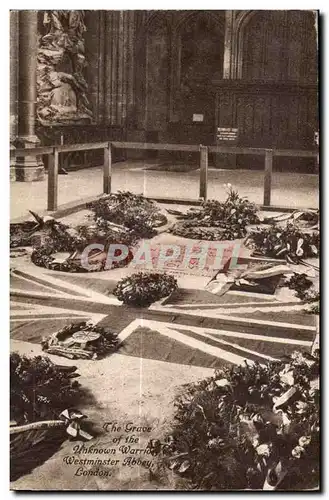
[216,11,318,171]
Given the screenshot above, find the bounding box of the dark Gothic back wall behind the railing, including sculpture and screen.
[10,10,318,176]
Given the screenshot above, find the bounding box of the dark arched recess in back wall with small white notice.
[168,11,225,162]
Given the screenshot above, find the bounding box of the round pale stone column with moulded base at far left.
[16,10,44,181]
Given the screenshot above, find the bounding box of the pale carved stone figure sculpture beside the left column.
[37,10,92,124]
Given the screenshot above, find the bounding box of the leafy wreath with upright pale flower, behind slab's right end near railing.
[171,186,259,240]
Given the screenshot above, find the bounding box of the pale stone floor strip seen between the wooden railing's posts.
[11,161,319,219]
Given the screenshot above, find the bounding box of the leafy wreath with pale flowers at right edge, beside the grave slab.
[248,223,320,262]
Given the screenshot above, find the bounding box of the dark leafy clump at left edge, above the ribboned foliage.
[10,352,82,424]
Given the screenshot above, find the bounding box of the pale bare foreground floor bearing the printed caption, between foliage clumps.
[11,341,213,491]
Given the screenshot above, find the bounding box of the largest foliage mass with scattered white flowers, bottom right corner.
[149,352,320,491]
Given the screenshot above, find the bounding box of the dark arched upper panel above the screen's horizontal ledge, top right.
[242,10,317,83]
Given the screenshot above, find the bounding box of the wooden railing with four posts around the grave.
[10,141,318,211]
